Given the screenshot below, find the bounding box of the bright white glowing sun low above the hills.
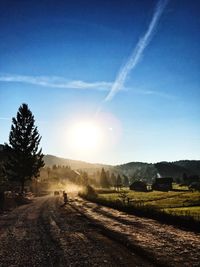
[69,121,102,151]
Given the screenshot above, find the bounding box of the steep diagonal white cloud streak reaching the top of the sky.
[104,0,168,101]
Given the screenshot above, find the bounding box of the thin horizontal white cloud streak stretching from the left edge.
[0,74,112,91]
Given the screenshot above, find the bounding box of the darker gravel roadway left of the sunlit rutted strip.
[0,197,153,267]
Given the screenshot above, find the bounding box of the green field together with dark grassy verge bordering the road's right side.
[80,189,200,231]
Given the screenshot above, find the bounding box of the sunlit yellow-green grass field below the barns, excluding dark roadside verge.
[84,189,200,222]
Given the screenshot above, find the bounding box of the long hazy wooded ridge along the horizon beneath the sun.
[44,155,200,182]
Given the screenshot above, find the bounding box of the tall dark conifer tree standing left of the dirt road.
[6,104,44,193]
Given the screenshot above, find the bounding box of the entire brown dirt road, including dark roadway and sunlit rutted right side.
[0,196,200,267]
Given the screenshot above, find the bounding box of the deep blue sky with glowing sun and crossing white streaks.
[0,0,200,164]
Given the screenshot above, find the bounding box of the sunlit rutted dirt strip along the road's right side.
[73,198,200,266]
